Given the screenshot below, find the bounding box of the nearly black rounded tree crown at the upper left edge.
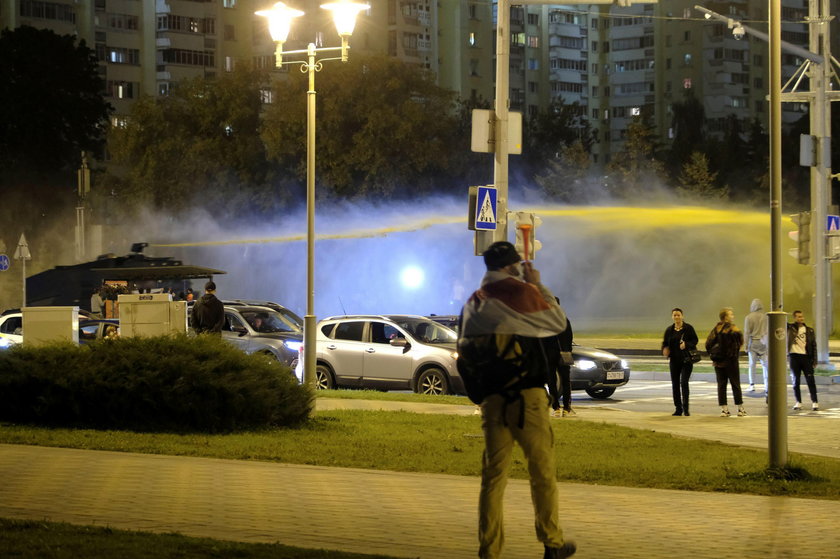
[0,26,111,182]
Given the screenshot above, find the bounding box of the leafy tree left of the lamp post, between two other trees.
[108,68,274,212]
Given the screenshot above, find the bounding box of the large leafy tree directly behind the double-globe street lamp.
[262,55,462,198]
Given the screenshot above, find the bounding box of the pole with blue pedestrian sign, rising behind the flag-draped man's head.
[493,0,511,241]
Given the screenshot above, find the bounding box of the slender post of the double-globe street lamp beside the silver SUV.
[303,43,317,386]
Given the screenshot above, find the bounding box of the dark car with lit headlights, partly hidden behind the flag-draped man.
[429,314,630,400]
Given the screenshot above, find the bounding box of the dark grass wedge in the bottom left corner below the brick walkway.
[0,518,394,559]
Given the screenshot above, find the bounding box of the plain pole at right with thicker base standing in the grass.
[765,0,787,468]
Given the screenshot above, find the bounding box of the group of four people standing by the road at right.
[662,299,819,417]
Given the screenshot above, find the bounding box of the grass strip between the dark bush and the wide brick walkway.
[0,404,840,500]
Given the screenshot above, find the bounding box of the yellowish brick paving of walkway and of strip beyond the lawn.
[0,399,840,559]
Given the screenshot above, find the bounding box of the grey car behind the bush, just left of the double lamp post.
[222,305,303,370]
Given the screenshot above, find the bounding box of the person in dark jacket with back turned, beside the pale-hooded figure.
[706,307,747,417]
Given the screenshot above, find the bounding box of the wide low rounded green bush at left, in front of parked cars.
[0,336,314,432]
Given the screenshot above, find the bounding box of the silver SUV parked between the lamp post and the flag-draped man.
[316,315,464,394]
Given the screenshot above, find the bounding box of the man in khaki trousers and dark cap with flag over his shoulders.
[458,241,576,559]
